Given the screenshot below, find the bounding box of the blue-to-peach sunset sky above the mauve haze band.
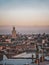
[0,0,49,26]
